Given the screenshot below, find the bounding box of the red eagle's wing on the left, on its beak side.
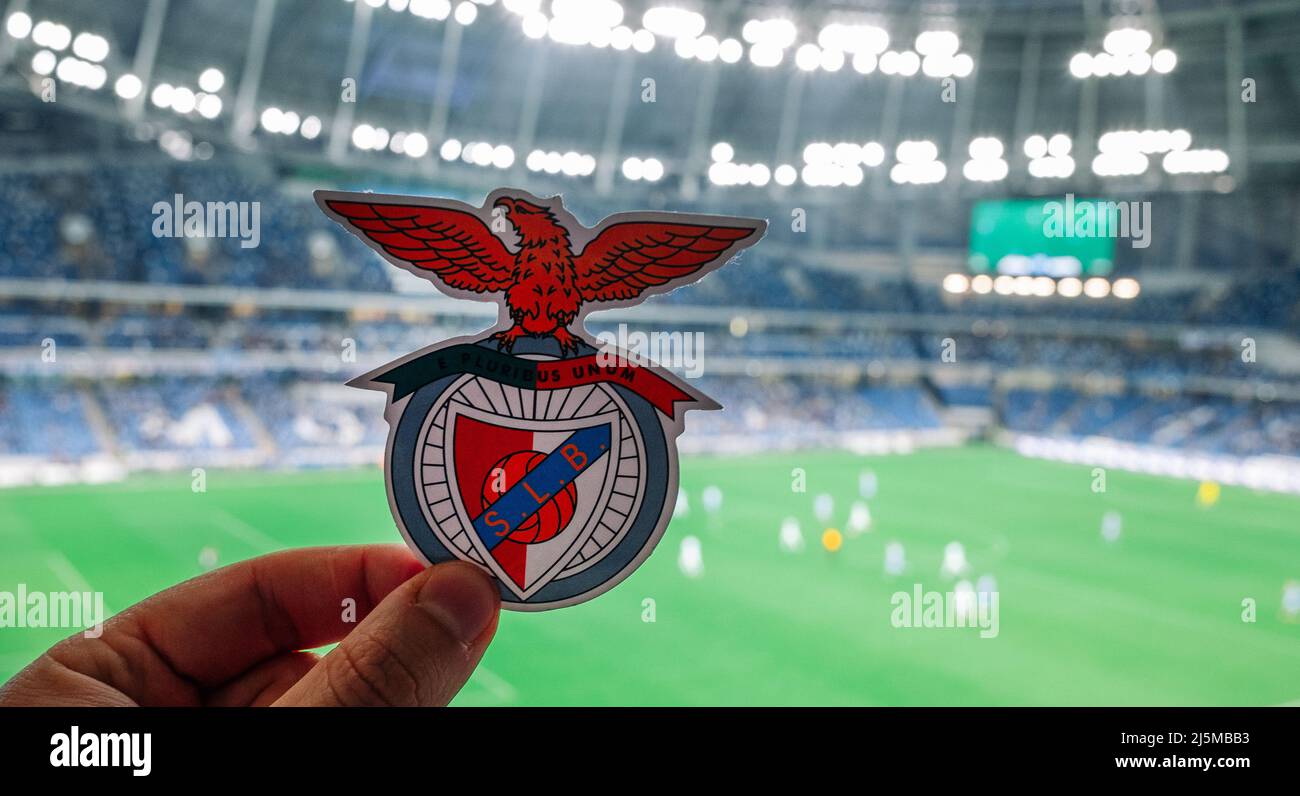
[325,199,515,293]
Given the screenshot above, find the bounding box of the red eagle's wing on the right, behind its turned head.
[575,219,762,302]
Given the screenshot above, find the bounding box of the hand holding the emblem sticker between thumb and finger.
[0,545,501,706]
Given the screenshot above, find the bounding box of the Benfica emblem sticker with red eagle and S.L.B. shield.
[316,189,767,611]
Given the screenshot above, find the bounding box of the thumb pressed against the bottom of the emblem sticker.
[276,561,501,708]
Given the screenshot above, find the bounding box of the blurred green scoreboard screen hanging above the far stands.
[967,196,1115,277]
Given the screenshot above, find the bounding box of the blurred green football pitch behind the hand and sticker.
[0,447,1300,705]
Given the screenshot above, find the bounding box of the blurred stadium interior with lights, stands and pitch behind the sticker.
[0,0,1300,706]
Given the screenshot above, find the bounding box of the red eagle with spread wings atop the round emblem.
[317,191,766,352]
